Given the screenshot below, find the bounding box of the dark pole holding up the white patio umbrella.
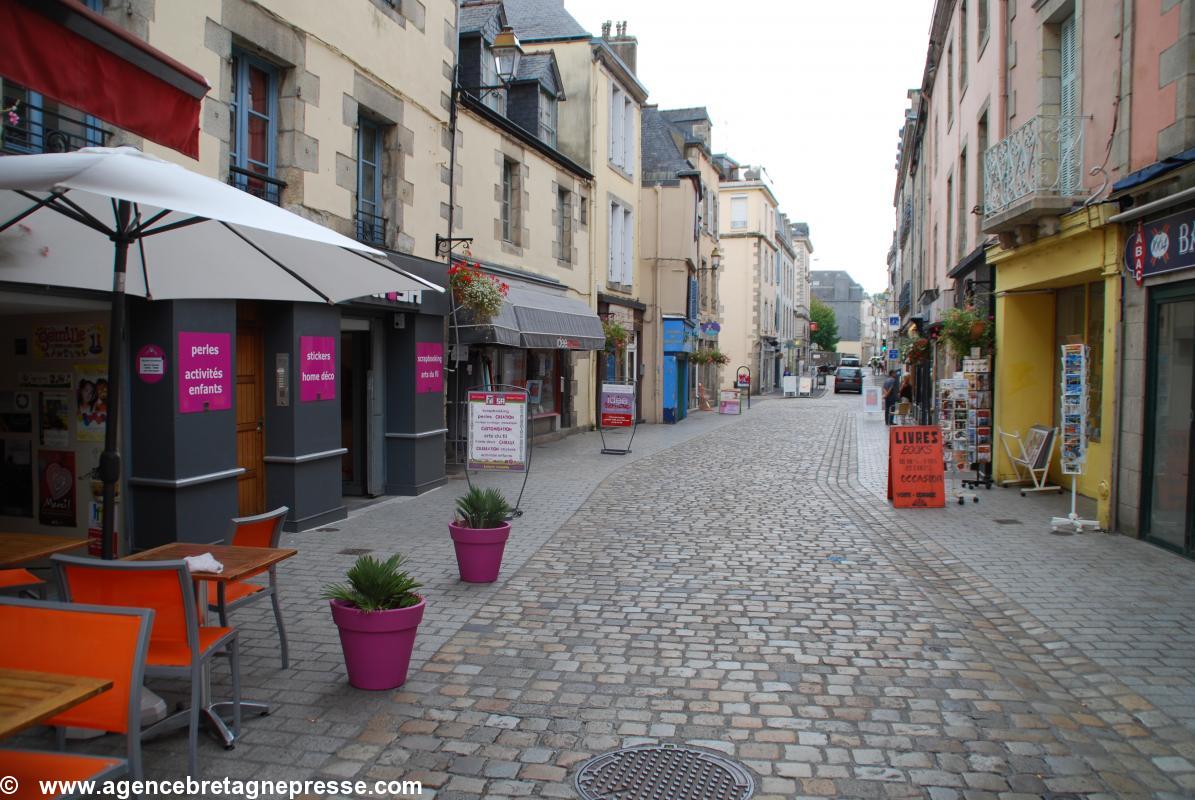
[99,200,133,560]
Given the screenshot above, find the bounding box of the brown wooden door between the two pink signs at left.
[237,303,265,517]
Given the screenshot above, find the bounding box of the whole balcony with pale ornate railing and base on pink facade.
[983,114,1085,233]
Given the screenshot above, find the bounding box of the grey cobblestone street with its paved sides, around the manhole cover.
[32,382,1195,800]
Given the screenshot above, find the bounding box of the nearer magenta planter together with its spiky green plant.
[323,555,425,691]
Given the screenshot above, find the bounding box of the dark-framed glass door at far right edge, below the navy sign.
[1141,288,1195,555]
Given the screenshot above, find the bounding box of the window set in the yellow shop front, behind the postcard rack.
[1054,281,1104,442]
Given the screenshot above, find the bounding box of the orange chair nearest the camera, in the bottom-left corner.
[0,598,153,787]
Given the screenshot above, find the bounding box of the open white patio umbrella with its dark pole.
[0,147,443,557]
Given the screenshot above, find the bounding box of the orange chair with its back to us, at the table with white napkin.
[50,554,240,775]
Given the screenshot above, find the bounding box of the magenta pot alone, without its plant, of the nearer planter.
[331,598,427,691]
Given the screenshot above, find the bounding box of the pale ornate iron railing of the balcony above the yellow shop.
[983,114,1084,216]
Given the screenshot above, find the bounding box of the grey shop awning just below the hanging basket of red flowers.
[459,283,606,350]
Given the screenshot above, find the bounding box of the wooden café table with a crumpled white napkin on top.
[124,542,299,750]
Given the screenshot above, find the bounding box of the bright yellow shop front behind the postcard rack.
[987,206,1123,529]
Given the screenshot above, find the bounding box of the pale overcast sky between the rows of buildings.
[564,0,933,292]
